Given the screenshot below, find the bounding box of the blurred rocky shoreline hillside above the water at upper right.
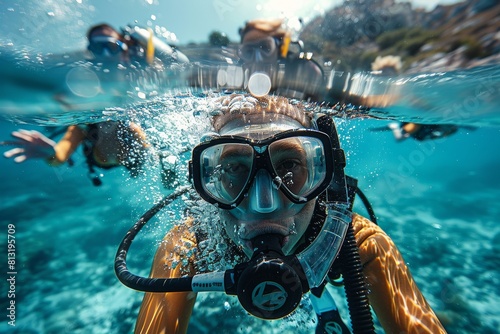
[300,0,500,73]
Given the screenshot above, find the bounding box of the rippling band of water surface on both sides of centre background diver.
[0,43,500,127]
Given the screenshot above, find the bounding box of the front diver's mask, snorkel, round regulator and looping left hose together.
[115,116,351,319]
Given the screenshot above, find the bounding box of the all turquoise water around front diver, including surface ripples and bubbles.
[0,2,500,334]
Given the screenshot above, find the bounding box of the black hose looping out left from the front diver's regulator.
[115,186,193,292]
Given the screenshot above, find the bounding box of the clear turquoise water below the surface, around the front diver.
[0,89,500,333]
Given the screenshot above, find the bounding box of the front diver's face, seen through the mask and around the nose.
[216,134,315,257]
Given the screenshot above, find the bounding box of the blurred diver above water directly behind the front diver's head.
[238,19,325,102]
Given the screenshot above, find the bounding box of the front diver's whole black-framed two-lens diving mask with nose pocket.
[190,129,333,212]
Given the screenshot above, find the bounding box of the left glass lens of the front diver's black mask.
[200,144,253,204]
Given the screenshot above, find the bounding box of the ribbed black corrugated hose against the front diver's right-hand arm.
[339,223,375,334]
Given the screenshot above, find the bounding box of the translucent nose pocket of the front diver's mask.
[249,169,279,213]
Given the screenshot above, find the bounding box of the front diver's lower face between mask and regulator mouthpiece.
[219,199,316,258]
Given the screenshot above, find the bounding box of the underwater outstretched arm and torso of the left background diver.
[4,121,149,186]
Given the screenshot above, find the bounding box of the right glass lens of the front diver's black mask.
[269,136,326,197]
